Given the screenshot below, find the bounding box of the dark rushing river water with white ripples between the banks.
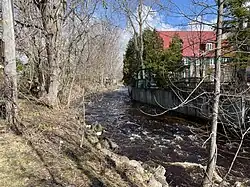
[86,87,249,186]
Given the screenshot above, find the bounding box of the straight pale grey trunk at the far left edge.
[2,0,17,124]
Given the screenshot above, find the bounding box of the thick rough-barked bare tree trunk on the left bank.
[37,0,64,107]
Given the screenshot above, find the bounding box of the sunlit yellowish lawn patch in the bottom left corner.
[0,134,48,187]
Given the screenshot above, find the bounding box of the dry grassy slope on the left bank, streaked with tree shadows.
[0,100,136,187]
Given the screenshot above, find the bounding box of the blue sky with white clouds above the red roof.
[94,0,216,30]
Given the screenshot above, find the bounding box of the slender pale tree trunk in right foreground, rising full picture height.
[203,0,224,187]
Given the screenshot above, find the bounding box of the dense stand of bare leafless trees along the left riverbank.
[15,0,121,106]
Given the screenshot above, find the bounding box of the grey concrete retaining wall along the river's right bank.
[129,87,250,128]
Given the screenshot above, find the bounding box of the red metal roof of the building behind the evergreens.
[158,31,216,57]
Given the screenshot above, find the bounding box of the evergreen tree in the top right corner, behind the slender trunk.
[224,0,250,83]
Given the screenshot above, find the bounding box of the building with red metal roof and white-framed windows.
[158,31,229,79]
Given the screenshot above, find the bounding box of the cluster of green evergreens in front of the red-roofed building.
[123,29,182,87]
